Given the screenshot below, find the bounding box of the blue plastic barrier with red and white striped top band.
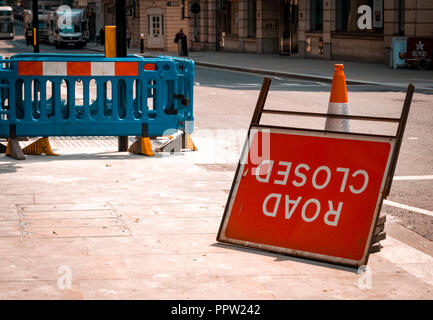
[0,54,194,137]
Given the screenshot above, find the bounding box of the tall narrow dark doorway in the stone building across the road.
[280,0,298,55]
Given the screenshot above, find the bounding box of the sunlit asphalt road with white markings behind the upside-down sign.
[0,22,433,240]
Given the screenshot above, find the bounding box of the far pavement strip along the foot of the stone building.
[85,43,433,93]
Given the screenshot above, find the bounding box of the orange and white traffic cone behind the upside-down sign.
[325,64,350,132]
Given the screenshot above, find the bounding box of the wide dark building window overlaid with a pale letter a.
[335,0,383,33]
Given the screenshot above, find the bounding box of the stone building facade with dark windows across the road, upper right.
[189,0,433,63]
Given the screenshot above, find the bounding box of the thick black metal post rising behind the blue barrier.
[116,0,128,151]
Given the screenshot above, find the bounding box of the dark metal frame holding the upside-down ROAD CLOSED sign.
[217,78,415,267]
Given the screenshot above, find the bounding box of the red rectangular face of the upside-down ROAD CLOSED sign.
[218,129,394,266]
